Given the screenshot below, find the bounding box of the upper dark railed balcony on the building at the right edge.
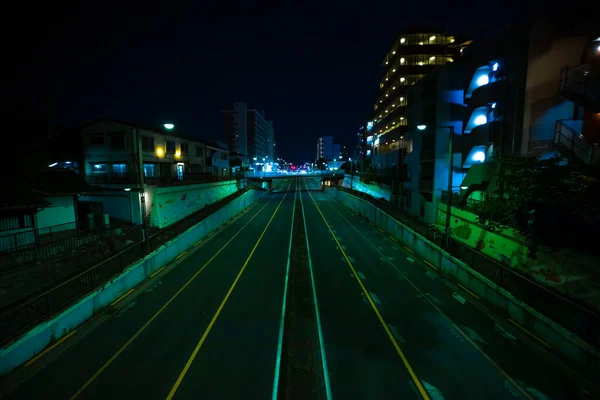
[560,64,600,113]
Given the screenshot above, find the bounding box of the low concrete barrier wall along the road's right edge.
[329,189,600,368]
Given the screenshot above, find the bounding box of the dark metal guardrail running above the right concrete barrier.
[337,187,600,347]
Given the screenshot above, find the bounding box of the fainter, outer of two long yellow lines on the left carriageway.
[69,195,271,400]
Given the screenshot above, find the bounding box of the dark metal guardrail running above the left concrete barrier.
[0,187,254,345]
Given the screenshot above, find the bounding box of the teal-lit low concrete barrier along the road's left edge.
[0,190,266,374]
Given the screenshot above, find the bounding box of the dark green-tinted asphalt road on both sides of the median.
[3,178,588,400]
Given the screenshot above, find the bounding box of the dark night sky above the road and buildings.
[5,1,544,161]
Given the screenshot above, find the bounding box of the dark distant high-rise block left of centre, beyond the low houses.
[221,103,275,161]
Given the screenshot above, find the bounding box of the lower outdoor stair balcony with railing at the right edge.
[554,120,600,165]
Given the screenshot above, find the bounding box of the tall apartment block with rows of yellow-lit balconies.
[365,30,470,176]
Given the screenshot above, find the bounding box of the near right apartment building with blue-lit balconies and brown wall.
[403,18,600,223]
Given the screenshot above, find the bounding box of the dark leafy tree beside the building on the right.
[473,157,595,255]
